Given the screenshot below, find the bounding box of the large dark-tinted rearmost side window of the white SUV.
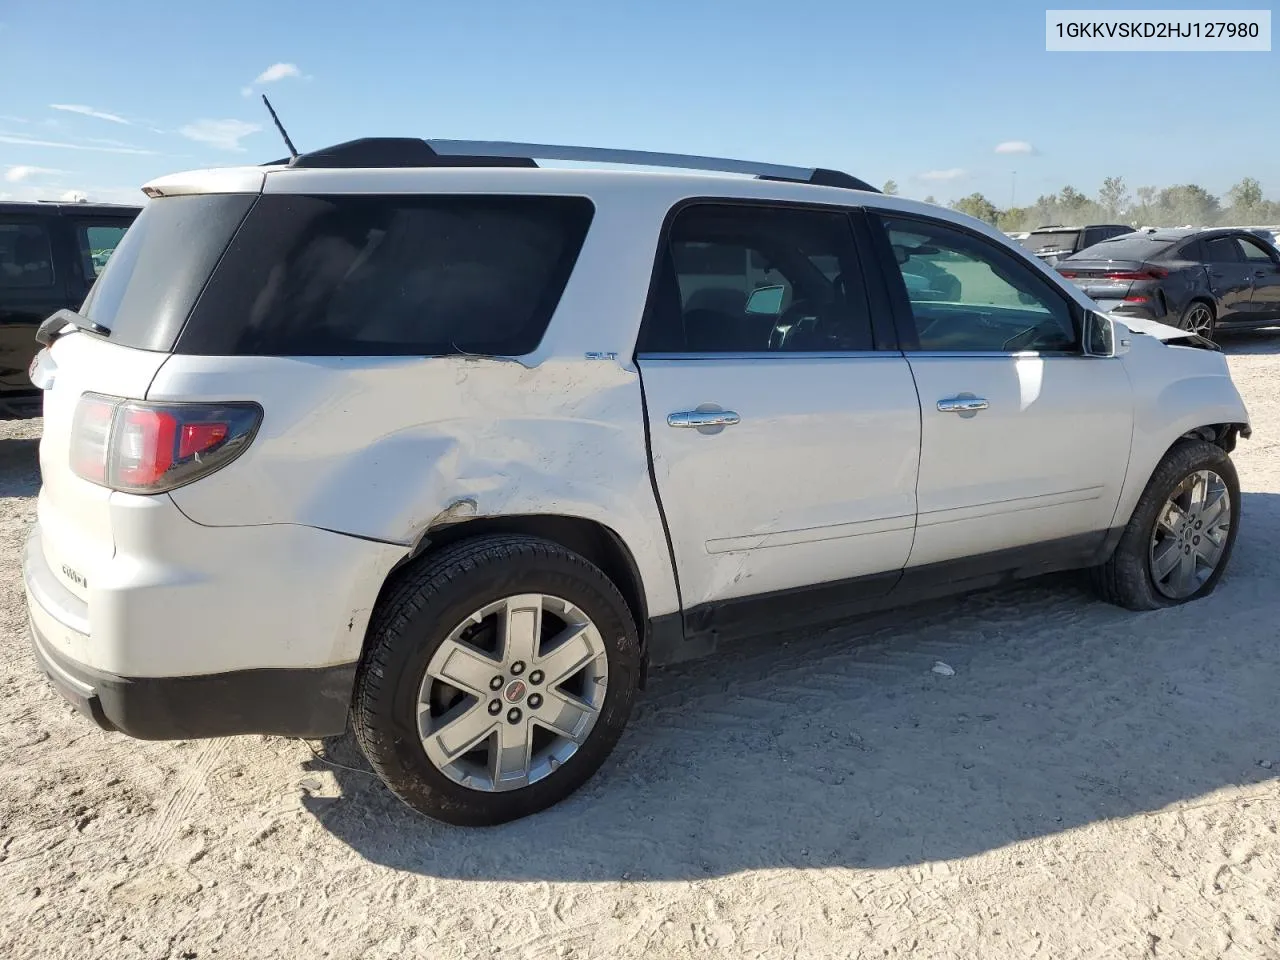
[180,195,593,356]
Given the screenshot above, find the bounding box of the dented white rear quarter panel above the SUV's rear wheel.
[148,356,678,616]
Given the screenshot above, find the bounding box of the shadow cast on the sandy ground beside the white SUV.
[303,493,1280,881]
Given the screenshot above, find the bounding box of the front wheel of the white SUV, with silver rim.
[1093,440,1240,611]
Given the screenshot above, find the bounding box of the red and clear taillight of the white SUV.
[70,393,262,493]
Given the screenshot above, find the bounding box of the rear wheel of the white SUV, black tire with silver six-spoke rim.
[352,535,640,826]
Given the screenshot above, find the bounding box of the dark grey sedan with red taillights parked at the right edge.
[1057,229,1280,338]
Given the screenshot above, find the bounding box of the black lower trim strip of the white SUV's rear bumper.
[31,616,356,740]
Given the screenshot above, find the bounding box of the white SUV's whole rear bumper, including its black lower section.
[23,508,399,740]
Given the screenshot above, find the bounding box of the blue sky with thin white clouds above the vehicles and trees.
[0,0,1280,206]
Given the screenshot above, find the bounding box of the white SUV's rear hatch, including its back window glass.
[38,195,256,599]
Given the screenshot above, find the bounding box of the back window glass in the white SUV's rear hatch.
[81,193,257,351]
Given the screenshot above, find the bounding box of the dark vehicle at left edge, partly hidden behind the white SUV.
[0,202,140,420]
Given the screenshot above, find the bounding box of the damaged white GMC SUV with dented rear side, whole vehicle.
[24,140,1249,824]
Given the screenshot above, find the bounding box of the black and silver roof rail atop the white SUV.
[271,137,879,193]
